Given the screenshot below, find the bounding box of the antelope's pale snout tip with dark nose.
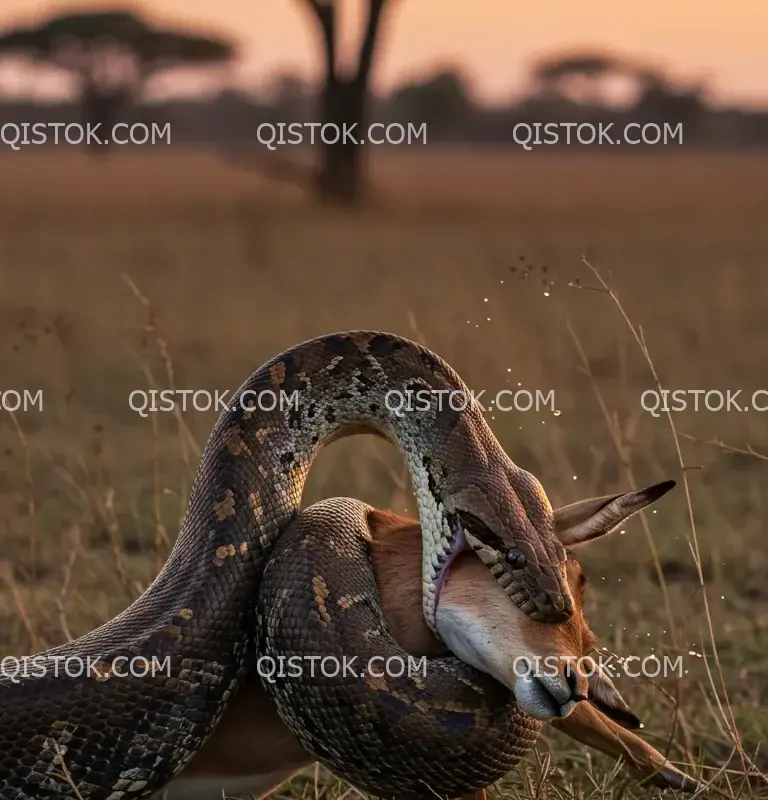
[514,658,587,721]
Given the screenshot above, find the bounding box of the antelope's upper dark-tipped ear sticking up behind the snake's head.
[554,481,675,547]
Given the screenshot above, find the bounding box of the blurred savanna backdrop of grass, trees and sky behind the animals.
[0,0,768,797]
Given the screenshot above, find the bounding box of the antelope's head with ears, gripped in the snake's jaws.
[437,481,675,728]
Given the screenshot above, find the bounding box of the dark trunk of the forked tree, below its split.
[314,78,367,207]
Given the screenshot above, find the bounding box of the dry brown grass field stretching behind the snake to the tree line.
[0,151,768,800]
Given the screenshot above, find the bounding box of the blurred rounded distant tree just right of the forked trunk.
[388,69,474,134]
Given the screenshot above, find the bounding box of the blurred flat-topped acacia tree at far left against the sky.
[0,10,234,152]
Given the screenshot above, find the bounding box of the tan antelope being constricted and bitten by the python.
[153,495,699,800]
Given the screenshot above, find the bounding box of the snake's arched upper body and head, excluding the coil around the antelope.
[0,331,573,800]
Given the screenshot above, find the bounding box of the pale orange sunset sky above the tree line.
[0,0,768,104]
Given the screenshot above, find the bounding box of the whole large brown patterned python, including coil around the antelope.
[0,331,574,800]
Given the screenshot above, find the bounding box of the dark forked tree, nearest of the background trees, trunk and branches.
[302,0,390,206]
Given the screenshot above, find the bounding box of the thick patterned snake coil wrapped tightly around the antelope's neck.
[258,497,540,800]
